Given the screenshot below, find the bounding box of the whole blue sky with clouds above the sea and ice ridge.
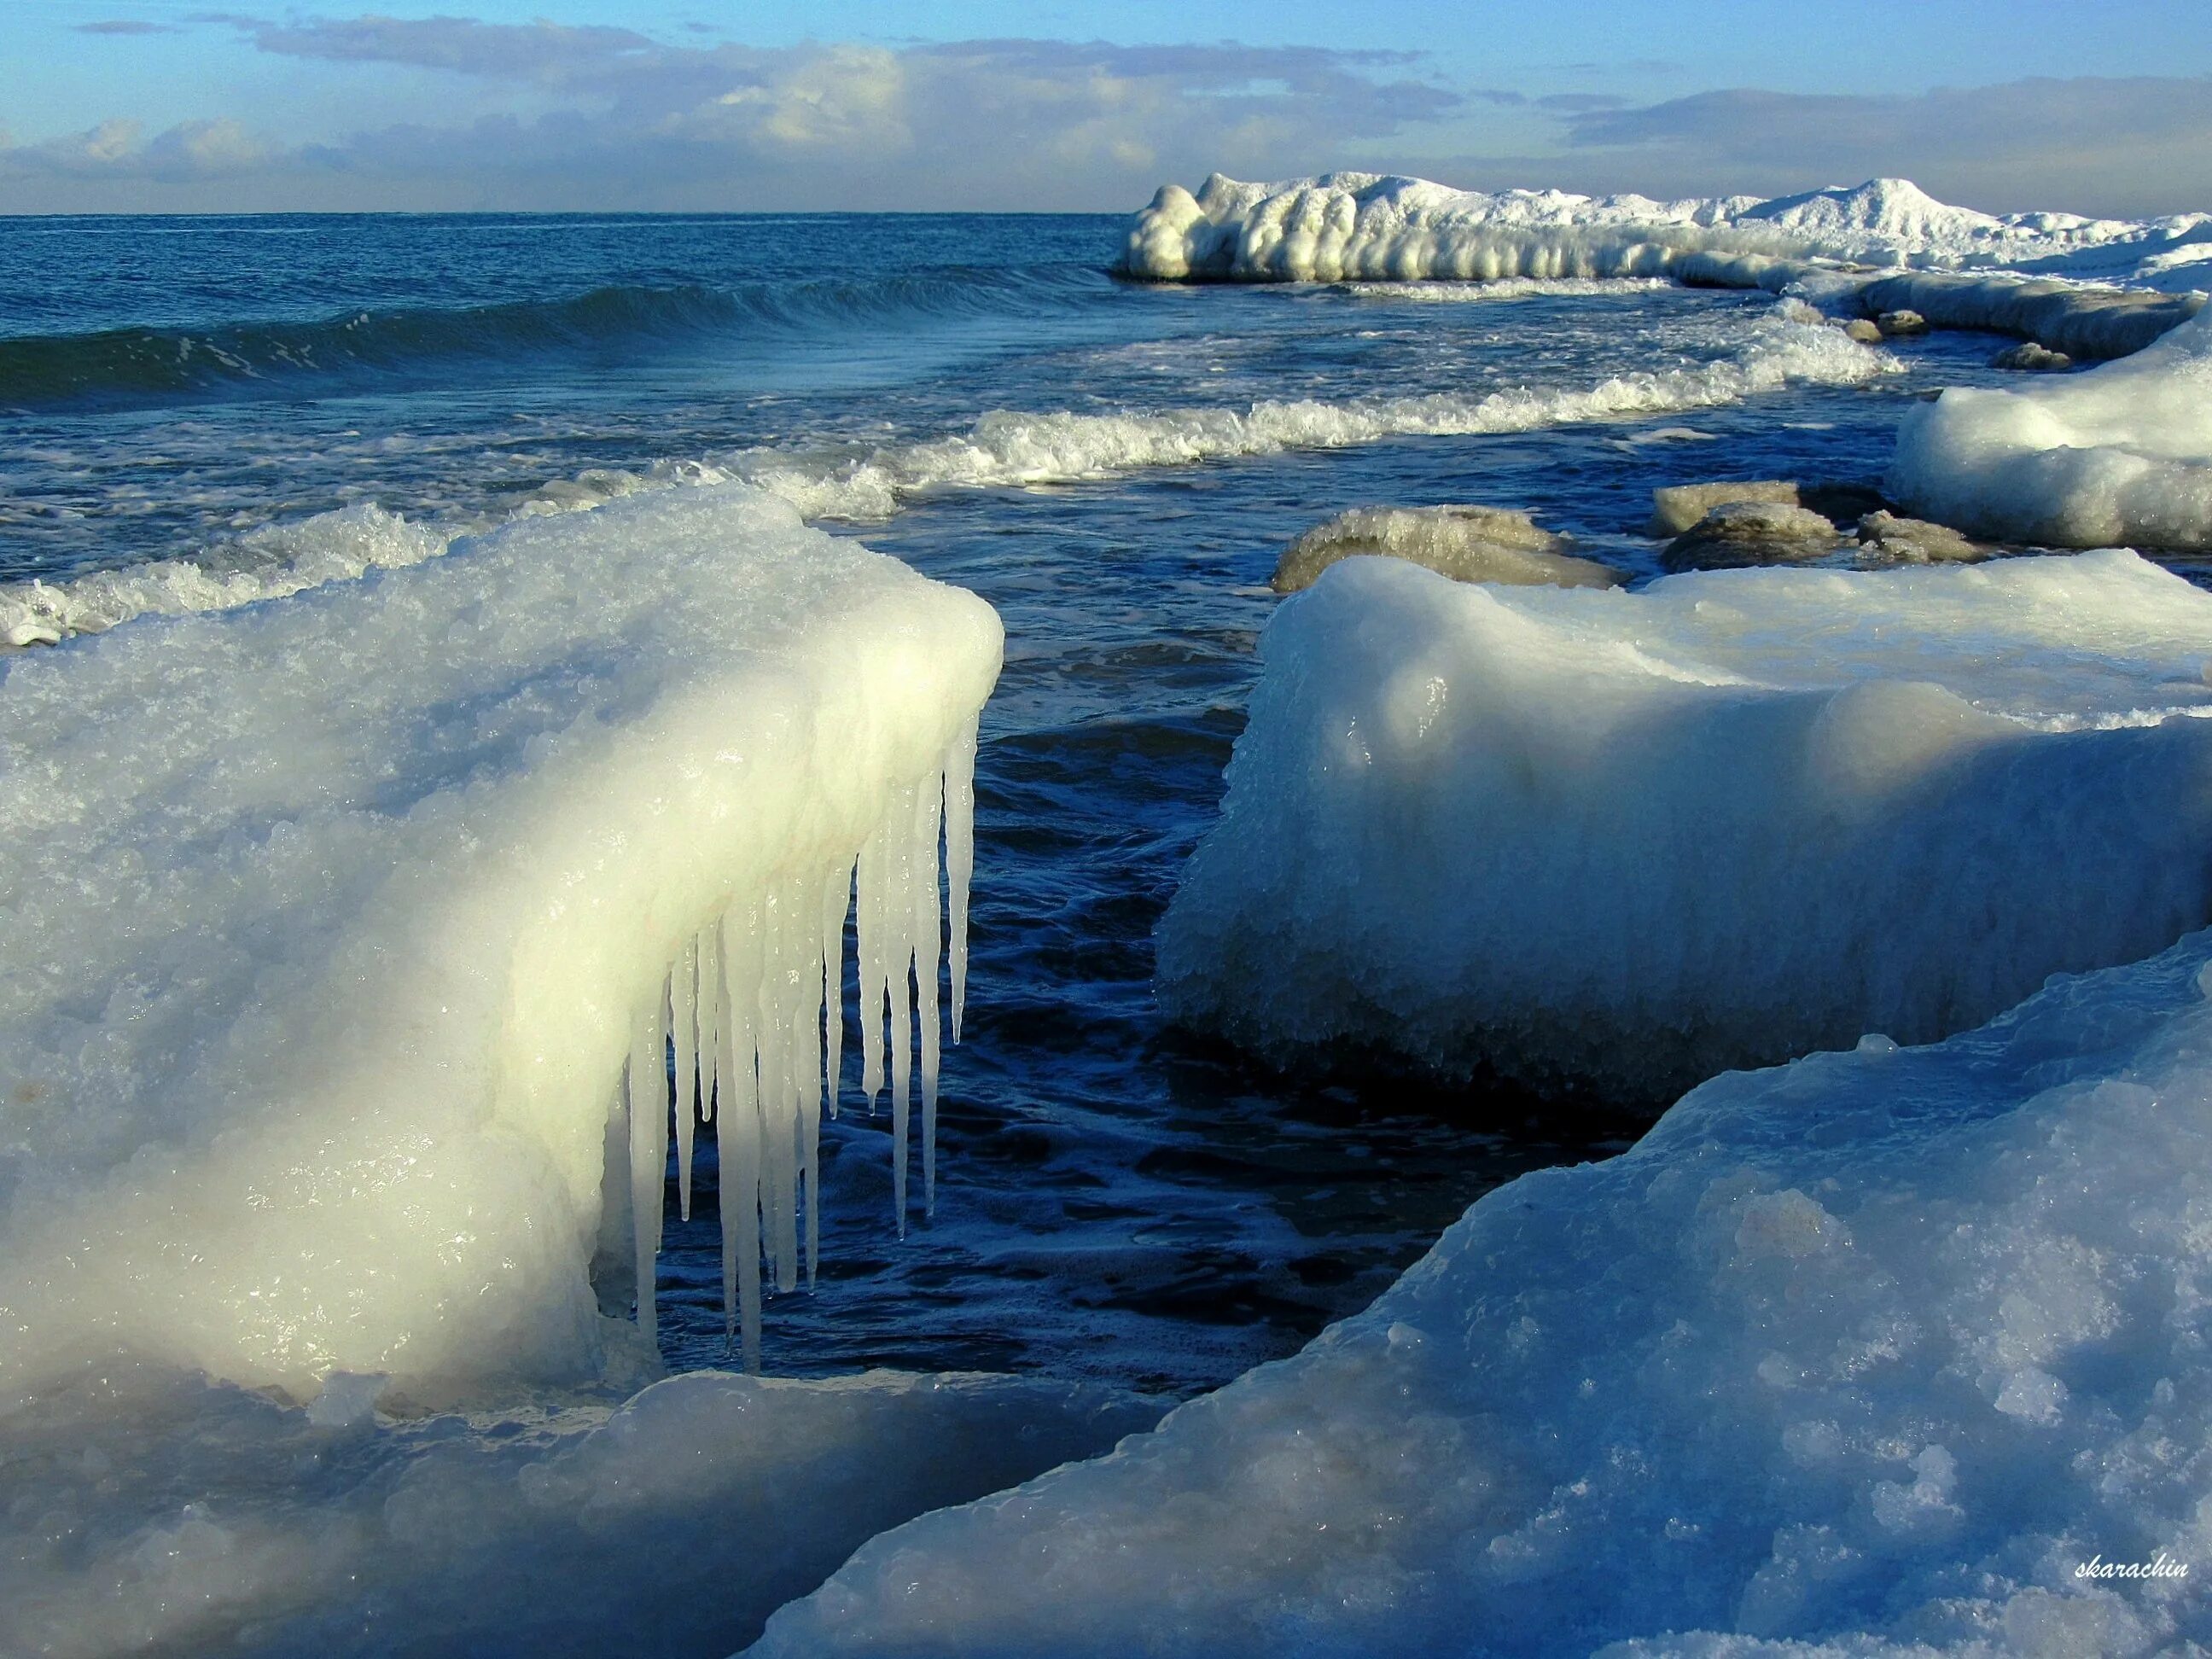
[13,0,2212,217]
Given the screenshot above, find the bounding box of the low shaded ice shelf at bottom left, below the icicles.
[0,1369,1159,1659]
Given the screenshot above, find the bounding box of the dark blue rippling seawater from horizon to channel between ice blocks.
[0,217,2034,1391]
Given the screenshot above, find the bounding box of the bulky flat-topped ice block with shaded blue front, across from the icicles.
[1159,553,2212,1102]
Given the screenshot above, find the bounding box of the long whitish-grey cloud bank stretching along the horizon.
[0,14,2212,214]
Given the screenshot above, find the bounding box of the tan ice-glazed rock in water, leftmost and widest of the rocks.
[1270,507,1626,593]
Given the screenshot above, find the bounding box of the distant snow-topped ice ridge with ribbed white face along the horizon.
[1120,172,2212,358]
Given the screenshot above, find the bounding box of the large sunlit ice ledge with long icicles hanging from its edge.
[0,486,1002,1398]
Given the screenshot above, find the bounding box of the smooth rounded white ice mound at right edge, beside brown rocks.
[1889,311,2212,549]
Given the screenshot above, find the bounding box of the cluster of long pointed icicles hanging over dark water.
[615,725,975,1371]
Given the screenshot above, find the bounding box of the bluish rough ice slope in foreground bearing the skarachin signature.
[754,934,2212,1659]
